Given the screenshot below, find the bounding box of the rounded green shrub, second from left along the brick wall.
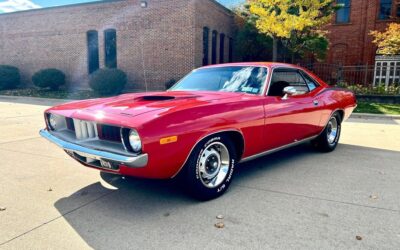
[32,69,65,90]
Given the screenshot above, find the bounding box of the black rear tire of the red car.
[311,112,342,152]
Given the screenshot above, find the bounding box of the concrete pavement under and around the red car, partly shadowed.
[0,97,400,249]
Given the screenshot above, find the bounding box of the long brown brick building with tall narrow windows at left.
[0,0,234,90]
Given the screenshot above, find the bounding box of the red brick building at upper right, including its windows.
[327,0,400,65]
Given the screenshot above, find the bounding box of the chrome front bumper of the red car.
[39,129,148,168]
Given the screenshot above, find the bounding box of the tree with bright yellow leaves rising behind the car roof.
[248,0,340,61]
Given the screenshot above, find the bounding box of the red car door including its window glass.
[265,68,322,150]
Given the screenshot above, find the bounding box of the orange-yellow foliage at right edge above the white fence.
[370,23,400,55]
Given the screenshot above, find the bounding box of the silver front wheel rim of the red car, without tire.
[197,142,230,188]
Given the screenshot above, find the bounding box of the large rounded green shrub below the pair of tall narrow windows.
[89,68,127,95]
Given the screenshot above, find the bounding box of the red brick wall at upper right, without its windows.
[327,0,397,65]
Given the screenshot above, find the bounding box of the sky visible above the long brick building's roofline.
[0,0,244,13]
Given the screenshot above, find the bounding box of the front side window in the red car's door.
[268,69,309,96]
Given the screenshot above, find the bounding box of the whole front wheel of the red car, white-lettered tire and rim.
[182,135,236,200]
